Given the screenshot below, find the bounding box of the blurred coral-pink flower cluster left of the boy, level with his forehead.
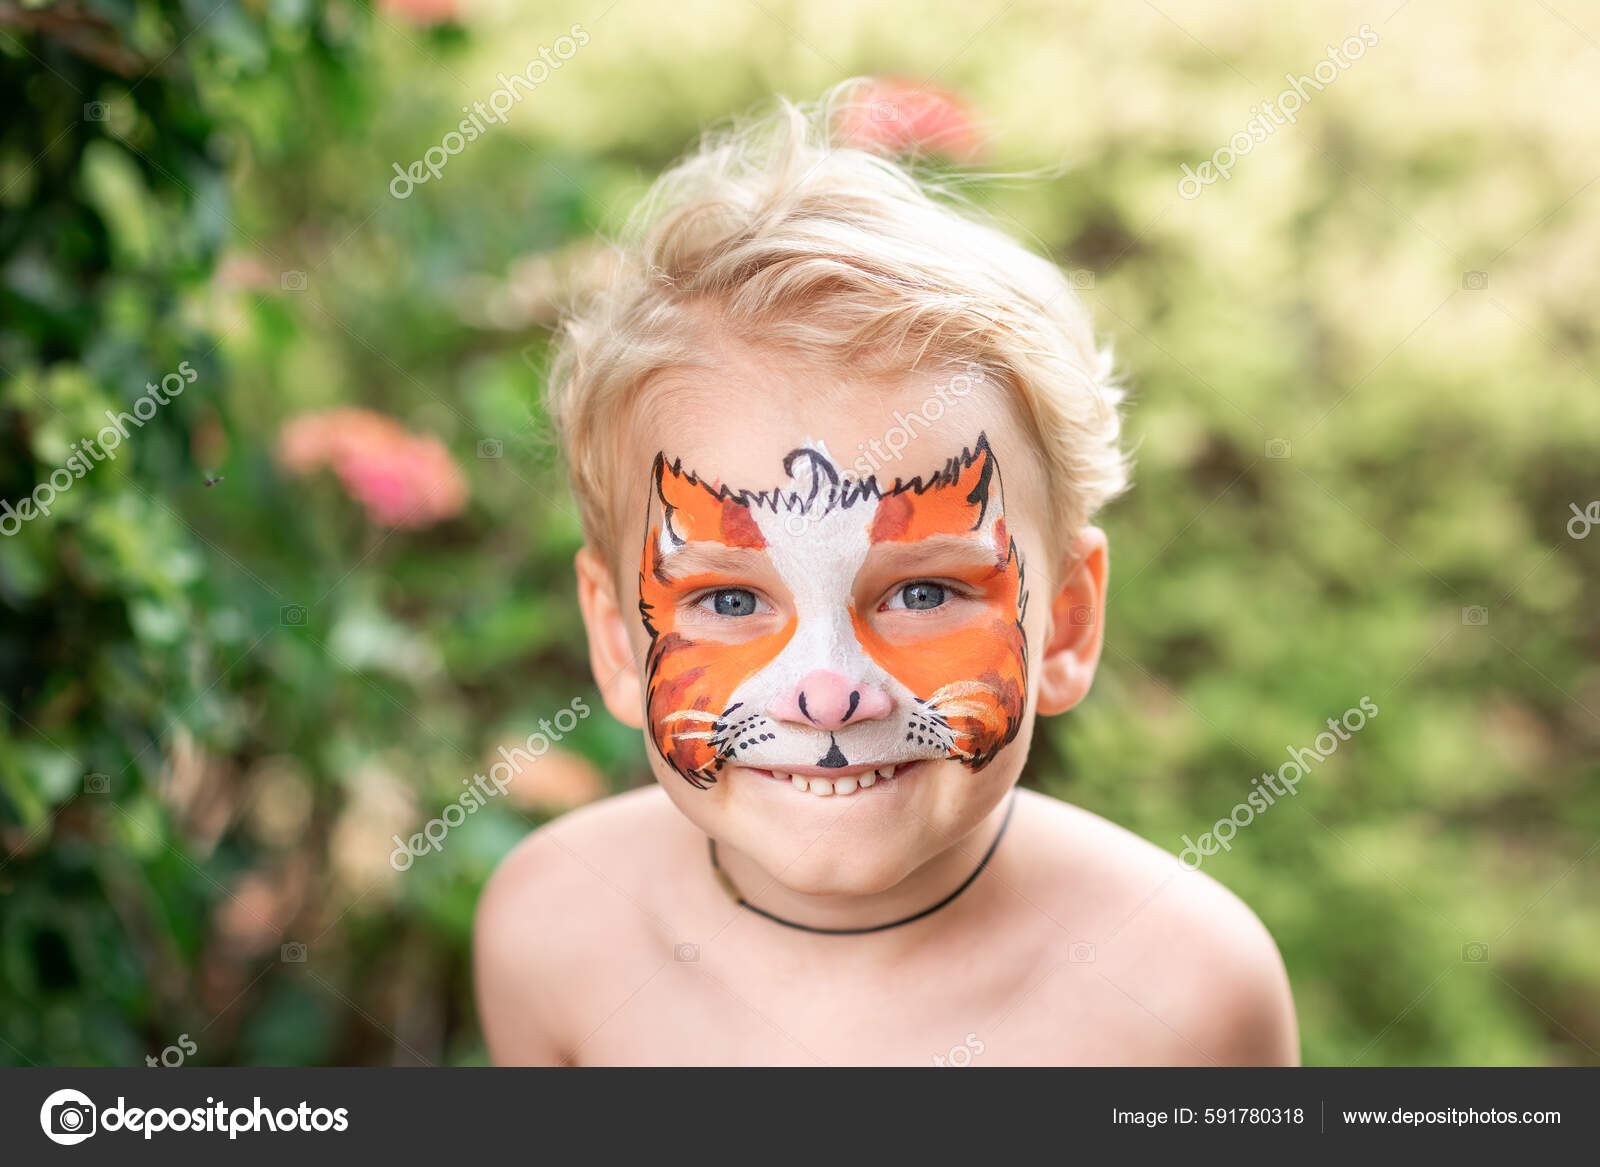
[278,408,467,527]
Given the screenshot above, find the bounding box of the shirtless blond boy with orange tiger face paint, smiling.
[475,86,1298,1066]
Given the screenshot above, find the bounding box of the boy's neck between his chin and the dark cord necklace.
[714,791,1014,932]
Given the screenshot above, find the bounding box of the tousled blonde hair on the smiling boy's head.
[547,80,1128,560]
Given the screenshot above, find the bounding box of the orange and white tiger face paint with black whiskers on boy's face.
[638,435,1027,788]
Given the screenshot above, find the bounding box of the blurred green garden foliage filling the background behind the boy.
[0,0,1600,1065]
